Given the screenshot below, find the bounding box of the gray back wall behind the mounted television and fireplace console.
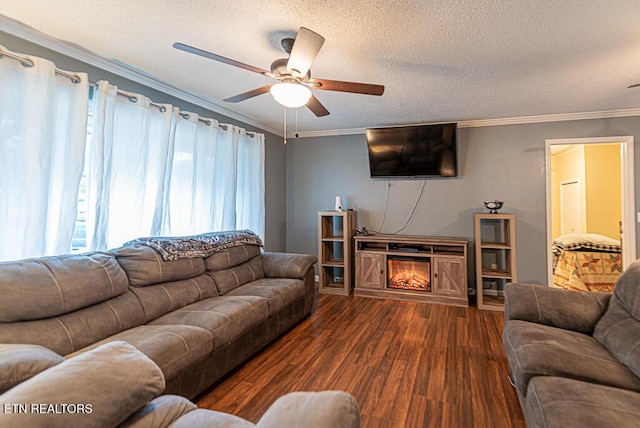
[287,117,640,284]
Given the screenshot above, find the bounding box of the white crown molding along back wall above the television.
[287,108,640,138]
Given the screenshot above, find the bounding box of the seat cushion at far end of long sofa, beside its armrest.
[225,278,305,316]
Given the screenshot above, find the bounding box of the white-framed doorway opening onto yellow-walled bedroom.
[545,136,636,286]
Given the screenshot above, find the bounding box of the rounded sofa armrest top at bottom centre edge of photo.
[256,391,360,428]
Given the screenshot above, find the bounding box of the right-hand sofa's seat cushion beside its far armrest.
[503,320,640,396]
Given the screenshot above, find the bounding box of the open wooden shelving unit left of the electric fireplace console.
[318,211,356,296]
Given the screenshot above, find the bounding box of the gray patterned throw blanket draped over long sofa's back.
[123,230,262,260]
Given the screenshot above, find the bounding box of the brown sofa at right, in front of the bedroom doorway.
[503,260,640,428]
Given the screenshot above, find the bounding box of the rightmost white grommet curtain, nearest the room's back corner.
[163,113,265,238]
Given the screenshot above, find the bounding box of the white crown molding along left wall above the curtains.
[0,14,282,136]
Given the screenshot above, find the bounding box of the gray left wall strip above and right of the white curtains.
[0,31,286,251]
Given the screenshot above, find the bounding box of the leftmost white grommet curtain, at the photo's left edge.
[0,46,89,260]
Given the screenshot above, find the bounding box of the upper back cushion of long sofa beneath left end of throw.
[111,245,205,287]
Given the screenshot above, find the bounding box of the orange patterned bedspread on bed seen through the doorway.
[553,250,622,292]
